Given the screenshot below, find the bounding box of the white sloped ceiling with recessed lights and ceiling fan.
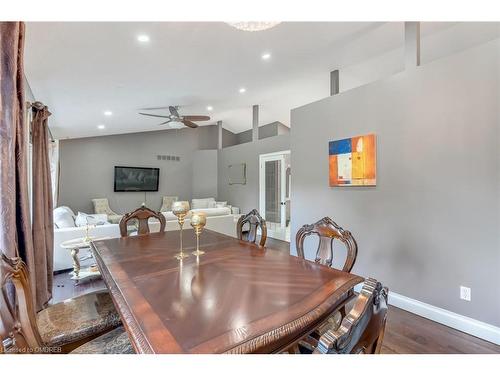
[25,22,500,138]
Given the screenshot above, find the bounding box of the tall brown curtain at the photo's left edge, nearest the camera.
[0,22,36,302]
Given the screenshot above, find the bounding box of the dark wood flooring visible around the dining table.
[51,238,500,354]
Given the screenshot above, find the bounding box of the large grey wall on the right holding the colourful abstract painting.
[292,40,500,326]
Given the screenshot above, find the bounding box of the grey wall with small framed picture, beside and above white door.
[218,135,293,216]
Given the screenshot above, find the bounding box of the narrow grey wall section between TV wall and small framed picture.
[193,150,217,198]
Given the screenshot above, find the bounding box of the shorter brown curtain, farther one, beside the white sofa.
[30,103,54,306]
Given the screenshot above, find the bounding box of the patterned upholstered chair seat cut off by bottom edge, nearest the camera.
[70,326,135,354]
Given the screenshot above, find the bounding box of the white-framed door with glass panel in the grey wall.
[259,151,290,229]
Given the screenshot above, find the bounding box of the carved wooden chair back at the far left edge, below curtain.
[0,251,43,353]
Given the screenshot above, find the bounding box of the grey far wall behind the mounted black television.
[58,126,217,213]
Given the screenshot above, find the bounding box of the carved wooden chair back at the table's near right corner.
[314,278,388,354]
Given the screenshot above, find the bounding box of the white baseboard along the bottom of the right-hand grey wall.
[355,284,500,345]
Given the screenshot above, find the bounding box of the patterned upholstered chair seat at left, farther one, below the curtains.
[36,290,121,347]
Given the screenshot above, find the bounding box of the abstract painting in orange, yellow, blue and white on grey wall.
[328,134,377,186]
